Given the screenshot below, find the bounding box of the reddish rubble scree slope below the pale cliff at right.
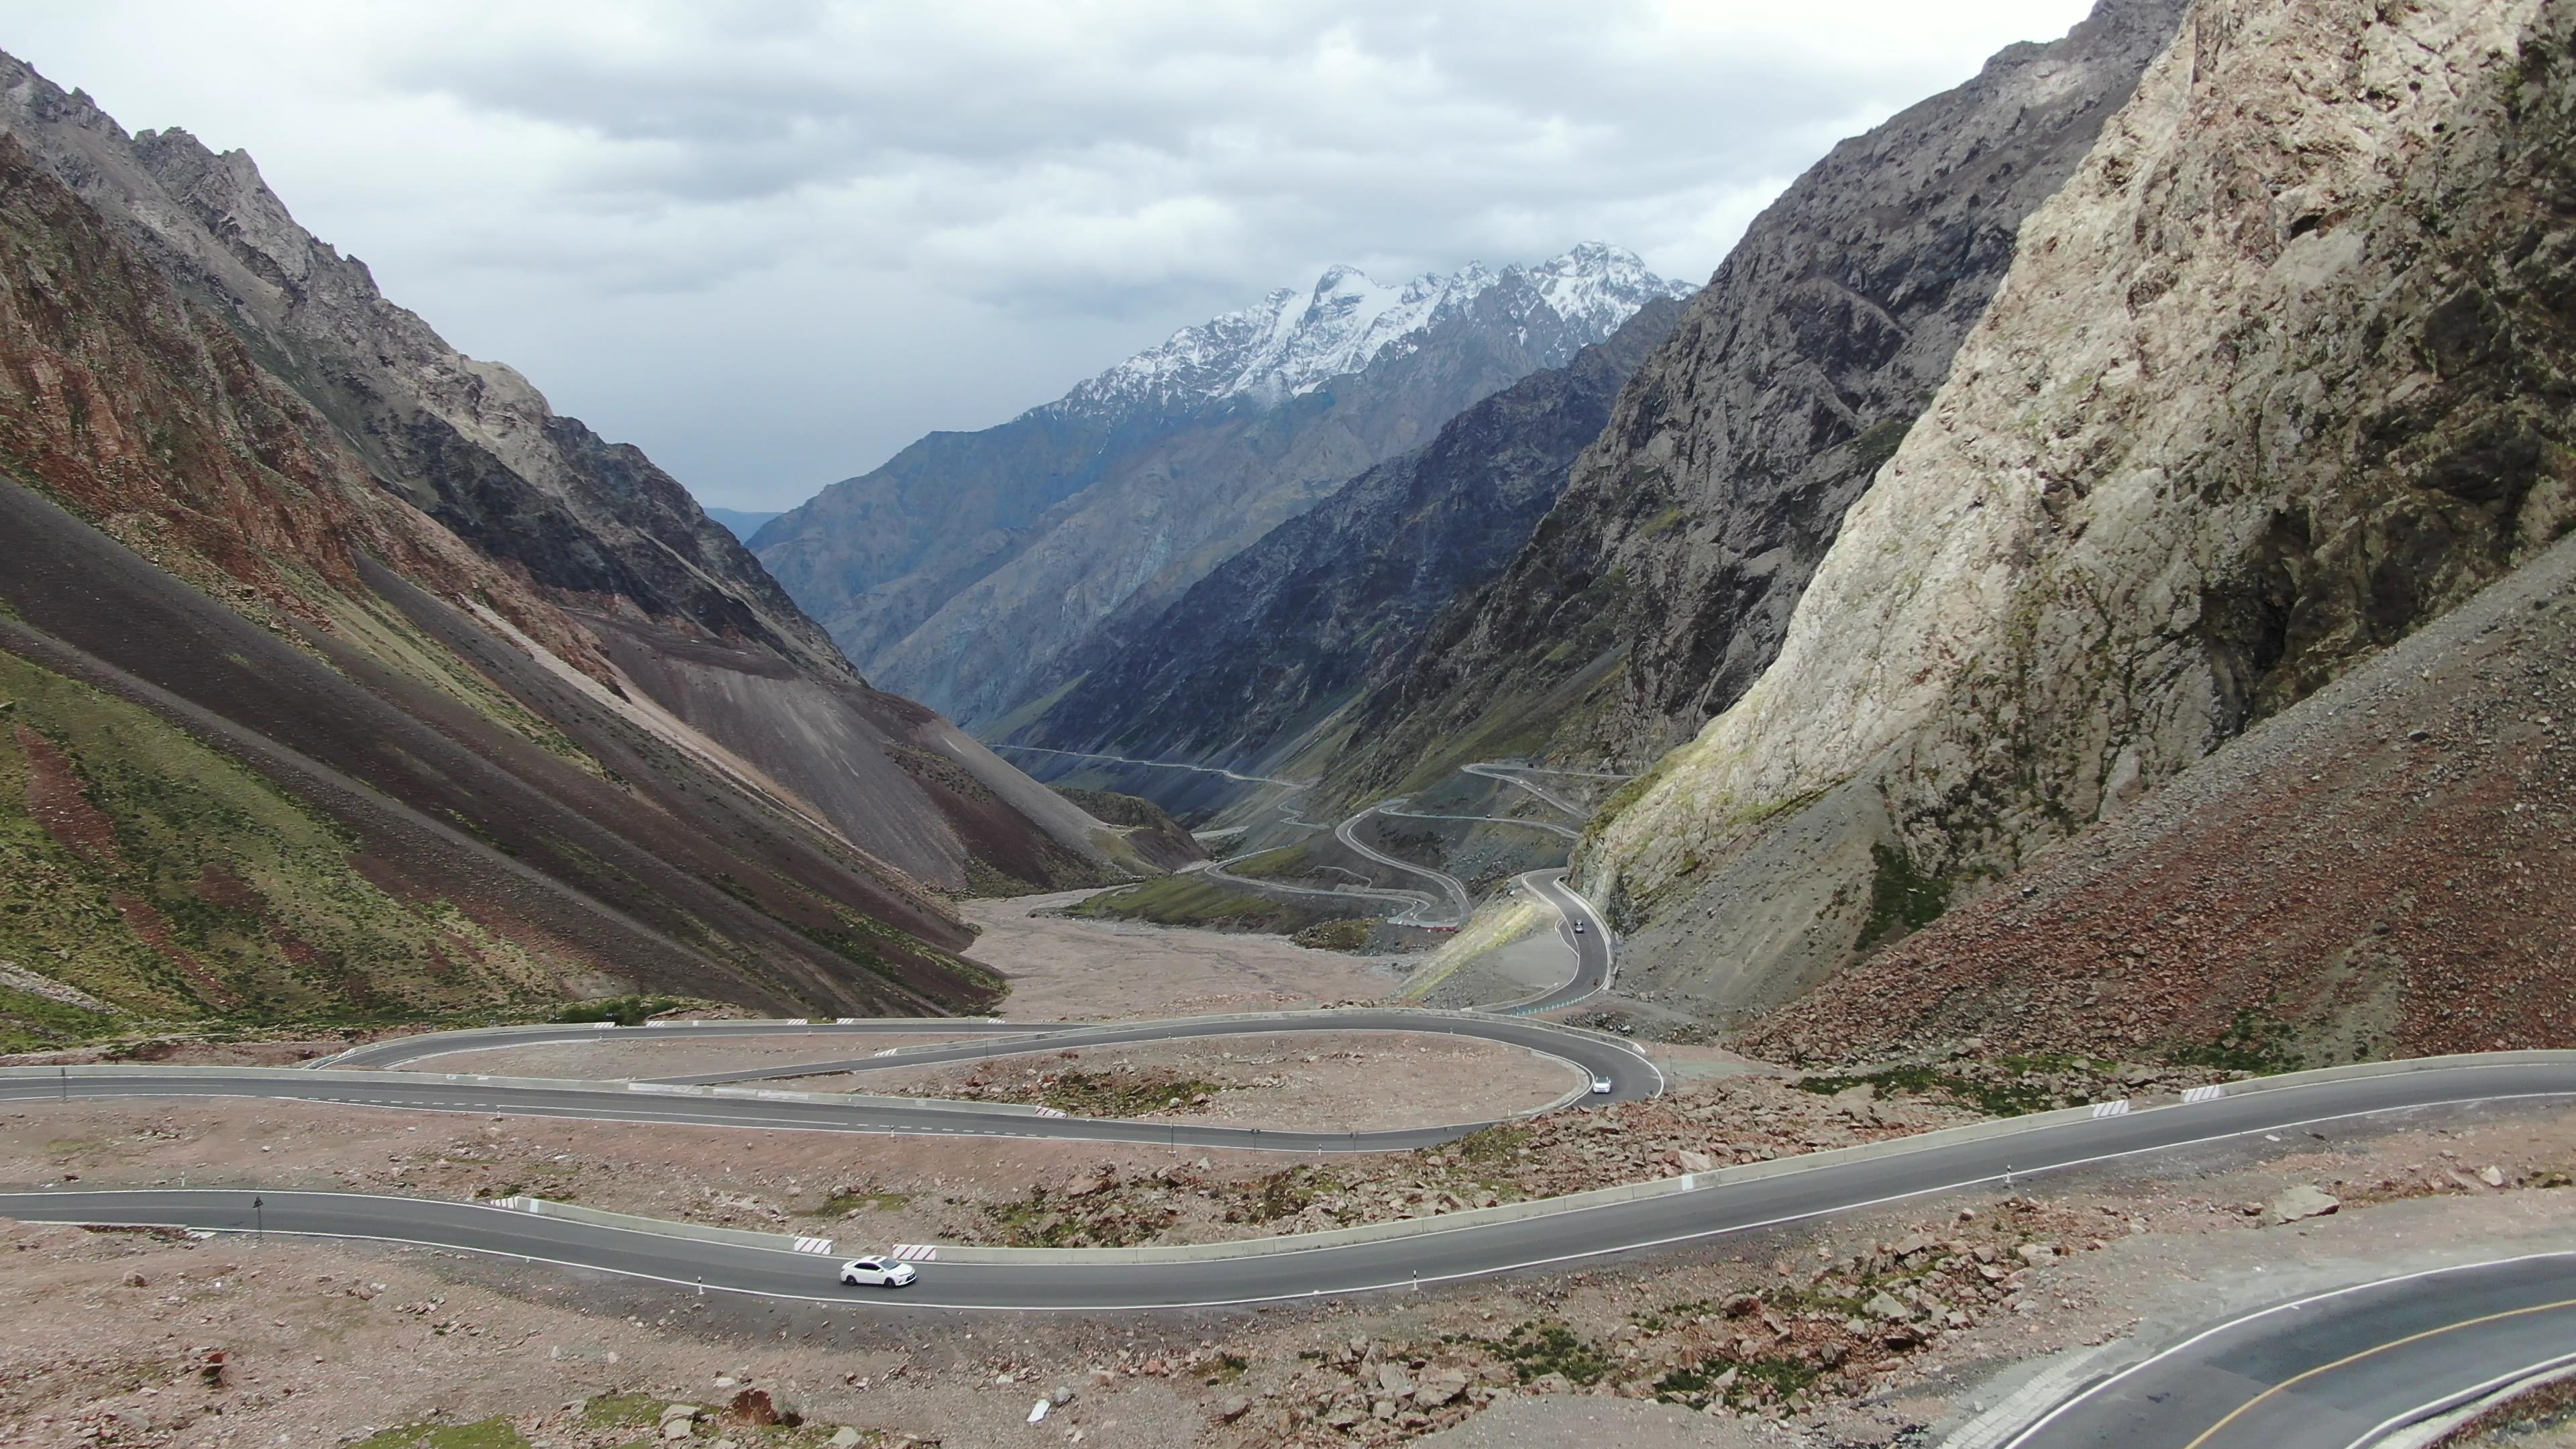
[1749,521,2576,1070]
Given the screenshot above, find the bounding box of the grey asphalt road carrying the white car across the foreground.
[0,1046,2576,1309]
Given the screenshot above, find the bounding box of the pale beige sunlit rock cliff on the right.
[1582,0,2576,1006]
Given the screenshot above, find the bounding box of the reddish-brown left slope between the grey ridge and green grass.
[0,137,991,1013]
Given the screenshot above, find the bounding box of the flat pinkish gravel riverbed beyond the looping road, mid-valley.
[961,890,1404,1021]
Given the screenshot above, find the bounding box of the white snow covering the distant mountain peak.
[1051,242,1695,410]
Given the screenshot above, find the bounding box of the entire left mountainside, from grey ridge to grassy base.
[0,62,1159,1031]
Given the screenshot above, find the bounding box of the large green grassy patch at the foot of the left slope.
[0,642,587,1026]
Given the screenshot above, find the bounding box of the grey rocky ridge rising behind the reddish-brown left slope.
[0,57,1110,890]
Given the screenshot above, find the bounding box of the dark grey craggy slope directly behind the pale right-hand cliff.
[1332,0,2184,799]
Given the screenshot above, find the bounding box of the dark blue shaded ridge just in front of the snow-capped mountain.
[1010,299,1682,773]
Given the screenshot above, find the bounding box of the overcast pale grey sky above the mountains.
[0,0,2089,508]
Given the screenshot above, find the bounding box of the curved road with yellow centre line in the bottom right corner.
[2009,1253,2576,1449]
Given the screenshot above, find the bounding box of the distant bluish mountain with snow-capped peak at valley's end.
[752,245,1680,724]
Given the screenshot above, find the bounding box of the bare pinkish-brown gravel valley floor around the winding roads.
[0,898,2576,1449]
